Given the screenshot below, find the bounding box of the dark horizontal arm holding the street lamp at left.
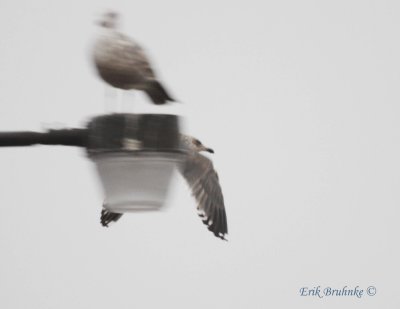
[0,129,88,147]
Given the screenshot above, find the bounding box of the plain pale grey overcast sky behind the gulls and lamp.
[0,0,400,309]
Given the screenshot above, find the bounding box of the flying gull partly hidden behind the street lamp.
[100,134,228,240]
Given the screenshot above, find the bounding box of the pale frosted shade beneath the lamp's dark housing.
[94,153,179,213]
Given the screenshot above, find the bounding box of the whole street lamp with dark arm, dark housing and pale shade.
[0,114,185,213]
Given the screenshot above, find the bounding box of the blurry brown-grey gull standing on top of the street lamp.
[93,12,174,104]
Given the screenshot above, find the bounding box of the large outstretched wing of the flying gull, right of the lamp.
[181,153,228,240]
